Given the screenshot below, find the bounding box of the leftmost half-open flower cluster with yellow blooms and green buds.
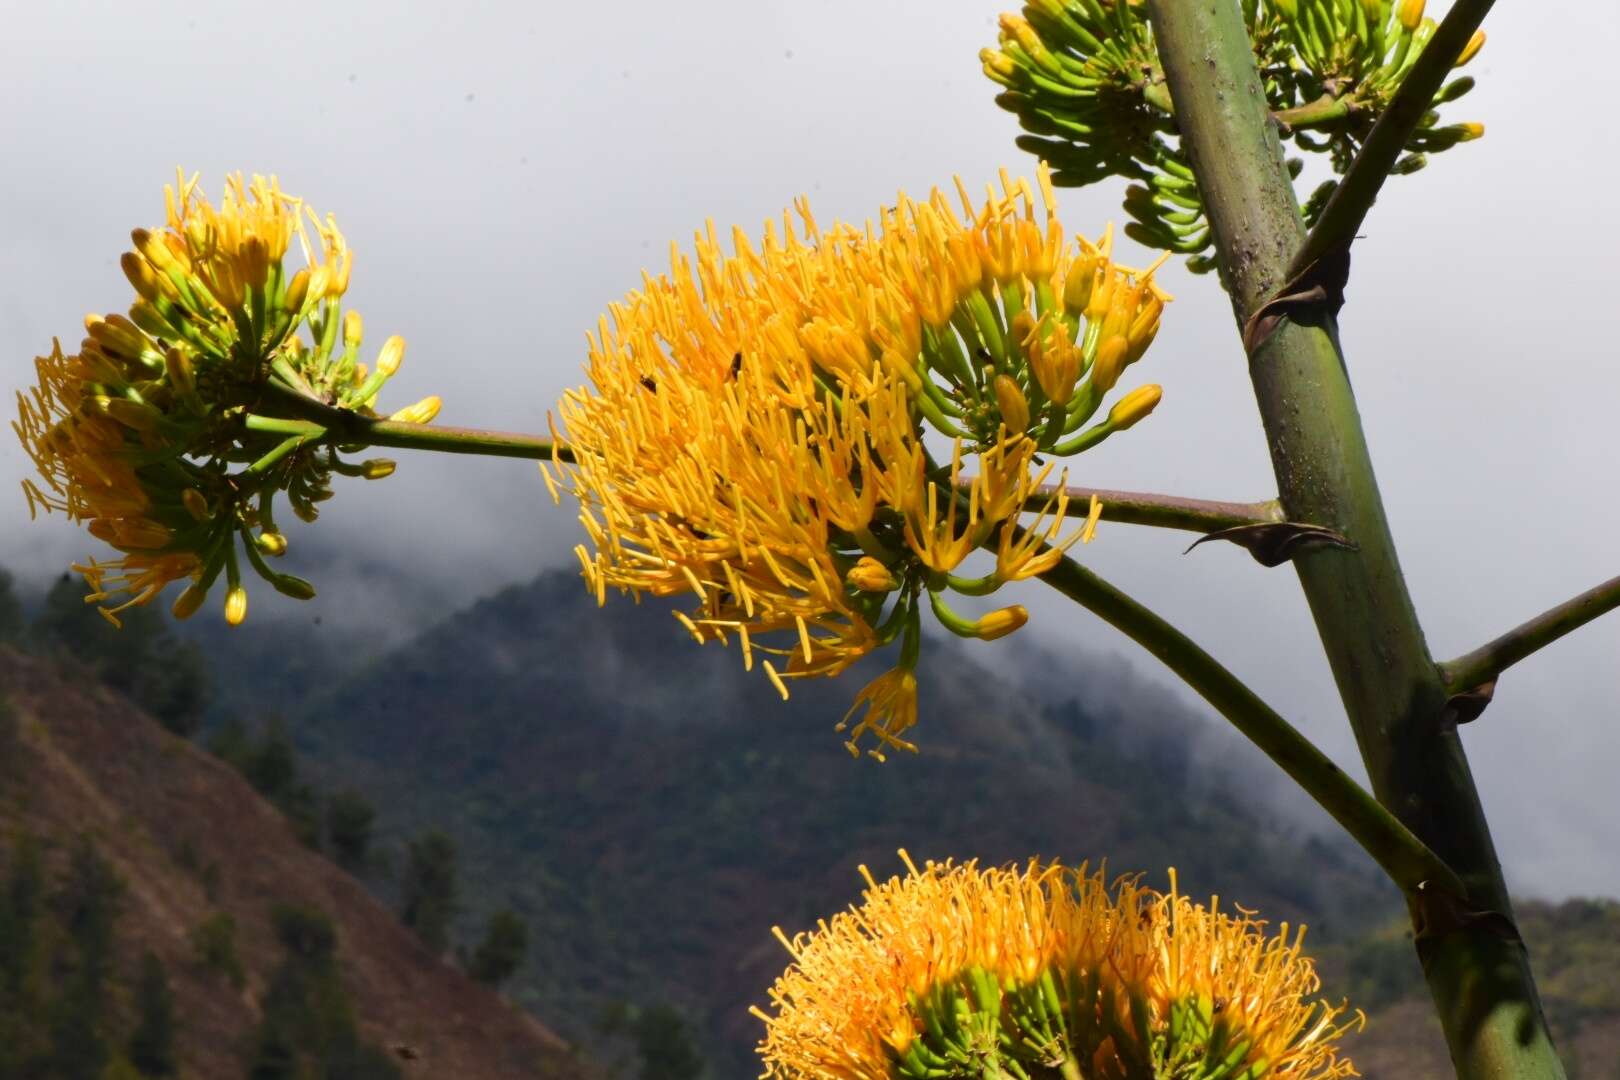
[15,176,437,625]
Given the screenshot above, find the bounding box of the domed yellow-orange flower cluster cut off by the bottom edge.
[753,852,1361,1080]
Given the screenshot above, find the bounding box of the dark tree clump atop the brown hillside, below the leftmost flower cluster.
[31,573,212,737]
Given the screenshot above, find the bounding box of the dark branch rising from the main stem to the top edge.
[1288,0,1495,277]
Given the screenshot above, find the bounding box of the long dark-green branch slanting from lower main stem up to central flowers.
[1021,529,1463,895]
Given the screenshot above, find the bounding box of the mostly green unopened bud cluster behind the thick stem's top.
[980,0,1484,272]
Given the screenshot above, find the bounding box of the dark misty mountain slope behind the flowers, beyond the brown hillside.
[295,573,1398,1075]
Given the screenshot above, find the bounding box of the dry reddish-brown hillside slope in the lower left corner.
[0,646,595,1080]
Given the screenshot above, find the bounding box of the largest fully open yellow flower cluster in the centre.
[548,170,1166,756]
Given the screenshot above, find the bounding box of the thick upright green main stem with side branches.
[1149,0,1563,1080]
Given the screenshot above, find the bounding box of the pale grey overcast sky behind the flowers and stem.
[0,0,1620,895]
